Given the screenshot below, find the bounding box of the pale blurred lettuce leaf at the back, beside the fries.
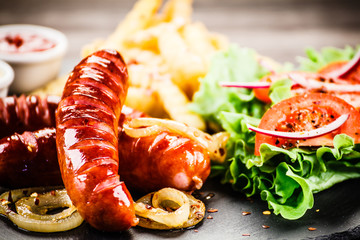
[190,45,269,125]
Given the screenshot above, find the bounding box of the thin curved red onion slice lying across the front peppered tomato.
[246,114,350,139]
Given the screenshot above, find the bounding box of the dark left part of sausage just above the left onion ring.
[0,128,62,188]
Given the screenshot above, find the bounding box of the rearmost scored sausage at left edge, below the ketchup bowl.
[0,95,60,138]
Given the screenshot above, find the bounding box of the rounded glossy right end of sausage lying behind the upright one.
[119,131,210,193]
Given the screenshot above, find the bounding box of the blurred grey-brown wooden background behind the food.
[0,0,360,72]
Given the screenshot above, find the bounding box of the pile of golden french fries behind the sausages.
[34,0,228,130]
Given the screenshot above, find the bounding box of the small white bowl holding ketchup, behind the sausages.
[0,24,68,93]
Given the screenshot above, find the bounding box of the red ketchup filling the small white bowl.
[0,32,56,53]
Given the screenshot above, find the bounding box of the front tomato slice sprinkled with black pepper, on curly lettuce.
[255,93,360,156]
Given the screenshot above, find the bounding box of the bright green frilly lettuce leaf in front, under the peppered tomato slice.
[220,112,360,220]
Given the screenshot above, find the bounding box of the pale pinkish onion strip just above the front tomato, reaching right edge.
[289,73,360,92]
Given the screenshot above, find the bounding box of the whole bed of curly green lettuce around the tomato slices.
[191,46,360,220]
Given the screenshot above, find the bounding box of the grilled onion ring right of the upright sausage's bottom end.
[135,188,205,230]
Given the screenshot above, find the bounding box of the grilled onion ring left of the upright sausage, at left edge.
[0,188,83,232]
